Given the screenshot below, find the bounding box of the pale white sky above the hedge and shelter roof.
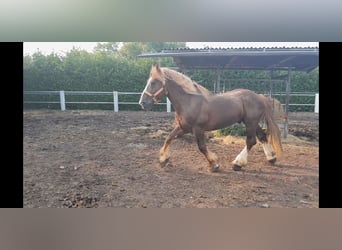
[24,42,318,55]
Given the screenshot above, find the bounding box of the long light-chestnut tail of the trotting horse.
[264,105,283,158]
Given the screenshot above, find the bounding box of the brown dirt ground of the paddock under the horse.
[23,111,319,208]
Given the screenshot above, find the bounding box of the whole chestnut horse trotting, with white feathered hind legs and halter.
[139,65,282,172]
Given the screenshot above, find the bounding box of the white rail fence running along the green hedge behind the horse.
[24,90,319,113]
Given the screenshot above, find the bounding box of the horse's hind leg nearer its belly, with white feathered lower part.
[232,125,256,171]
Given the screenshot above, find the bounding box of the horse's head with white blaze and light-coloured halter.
[139,64,167,110]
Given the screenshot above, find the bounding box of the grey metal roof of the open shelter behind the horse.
[138,47,319,72]
